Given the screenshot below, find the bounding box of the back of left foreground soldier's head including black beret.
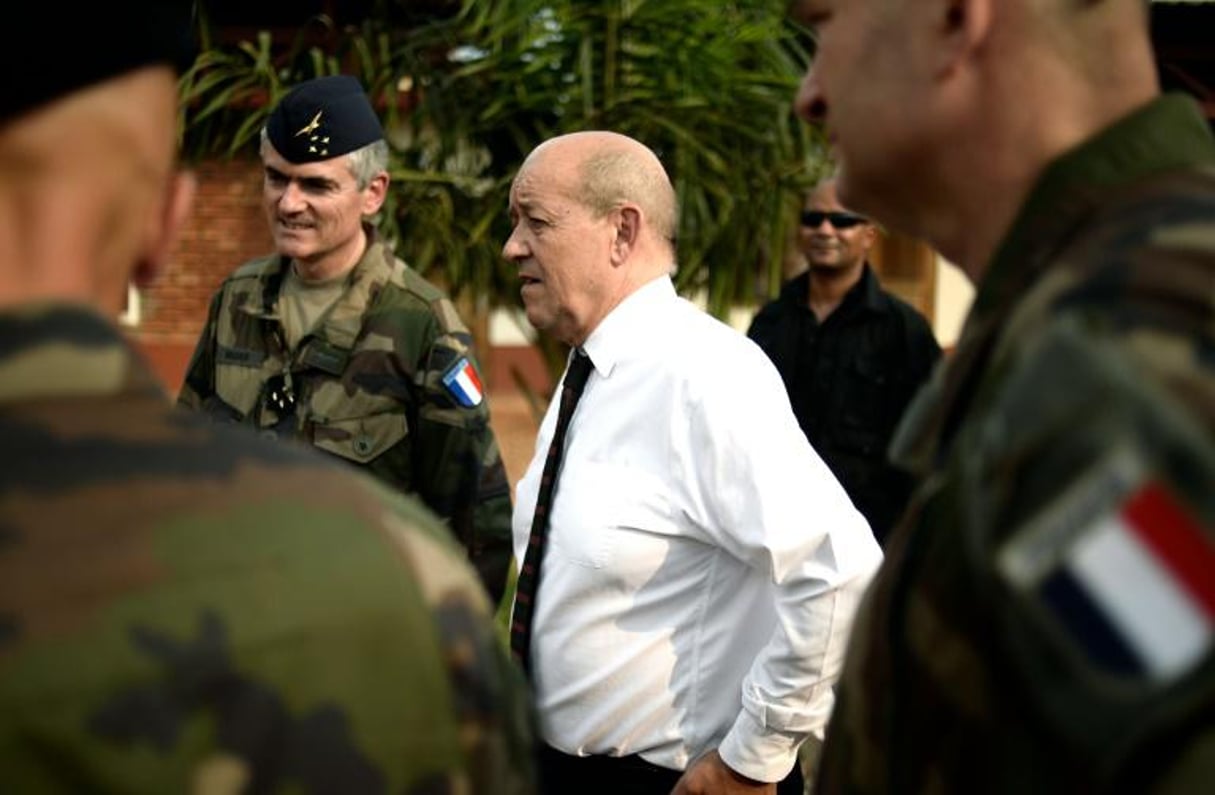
[0,0,194,314]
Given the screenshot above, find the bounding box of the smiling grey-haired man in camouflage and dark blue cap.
[177,75,512,602]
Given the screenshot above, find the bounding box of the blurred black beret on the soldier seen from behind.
[0,0,197,122]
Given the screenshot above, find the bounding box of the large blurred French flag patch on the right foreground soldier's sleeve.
[998,457,1215,684]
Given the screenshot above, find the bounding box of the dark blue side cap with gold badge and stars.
[266,74,384,163]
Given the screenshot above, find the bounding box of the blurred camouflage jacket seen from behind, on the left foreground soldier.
[0,305,533,793]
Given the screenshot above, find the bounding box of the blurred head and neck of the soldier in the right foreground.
[795,0,1159,277]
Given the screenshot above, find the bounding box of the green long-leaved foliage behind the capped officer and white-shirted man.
[182,0,824,354]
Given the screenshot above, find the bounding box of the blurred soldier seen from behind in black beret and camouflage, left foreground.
[0,0,533,794]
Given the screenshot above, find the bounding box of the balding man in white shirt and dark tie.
[503,131,881,795]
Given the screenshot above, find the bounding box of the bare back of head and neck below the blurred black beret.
[0,64,193,315]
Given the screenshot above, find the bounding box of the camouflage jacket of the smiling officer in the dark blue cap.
[177,229,512,602]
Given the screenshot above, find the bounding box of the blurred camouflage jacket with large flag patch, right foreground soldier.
[815,96,1215,795]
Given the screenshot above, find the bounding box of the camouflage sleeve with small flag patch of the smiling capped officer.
[413,298,513,610]
